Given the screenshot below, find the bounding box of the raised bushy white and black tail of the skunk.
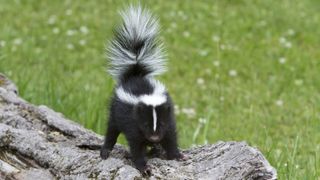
[108,6,166,80]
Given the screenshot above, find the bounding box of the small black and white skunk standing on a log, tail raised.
[100,6,184,175]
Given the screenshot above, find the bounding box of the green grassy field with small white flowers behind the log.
[0,0,320,179]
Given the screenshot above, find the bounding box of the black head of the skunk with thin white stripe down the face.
[134,97,172,142]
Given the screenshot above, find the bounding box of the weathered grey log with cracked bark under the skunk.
[0,74,276,179]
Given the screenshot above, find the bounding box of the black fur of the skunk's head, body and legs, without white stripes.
[101,77,183,172]
